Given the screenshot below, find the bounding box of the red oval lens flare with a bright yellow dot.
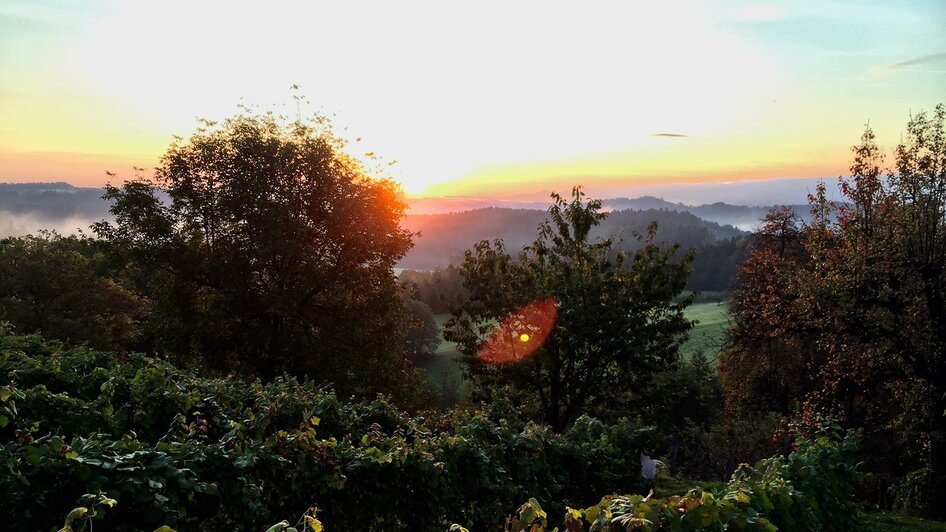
[478,298,557,364]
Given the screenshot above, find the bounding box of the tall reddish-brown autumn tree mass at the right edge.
[724,105,946,513]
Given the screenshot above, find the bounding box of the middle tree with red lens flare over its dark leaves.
[445,188,692,430]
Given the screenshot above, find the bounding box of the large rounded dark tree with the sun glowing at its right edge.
[95,113,411,394]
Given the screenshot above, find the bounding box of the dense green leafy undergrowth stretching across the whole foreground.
[0,330,857,531]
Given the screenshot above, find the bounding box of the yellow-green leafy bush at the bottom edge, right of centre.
[494,436,860,532]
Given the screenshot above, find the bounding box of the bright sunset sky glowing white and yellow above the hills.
[0,0,946,197]
